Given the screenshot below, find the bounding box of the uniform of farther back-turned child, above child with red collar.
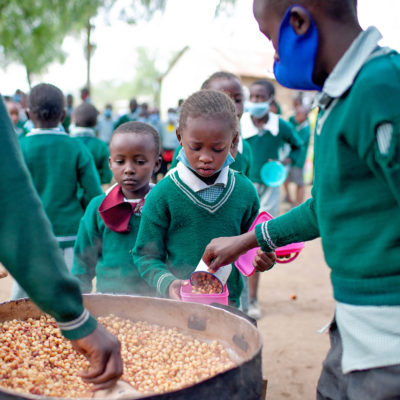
[70,127,112,184]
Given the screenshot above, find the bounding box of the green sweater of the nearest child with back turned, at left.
[20,130,102,248]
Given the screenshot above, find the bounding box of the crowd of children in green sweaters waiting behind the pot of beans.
[6,71,310,318]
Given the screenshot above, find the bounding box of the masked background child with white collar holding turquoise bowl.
[242,79,302,319]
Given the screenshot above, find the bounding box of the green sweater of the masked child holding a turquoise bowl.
[242,117,303,183]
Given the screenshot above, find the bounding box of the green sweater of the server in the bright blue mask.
[256,51,400,306]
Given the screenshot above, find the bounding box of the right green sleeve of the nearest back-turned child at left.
[78,143,103,208]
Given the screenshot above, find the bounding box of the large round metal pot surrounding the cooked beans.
[0,294,262,400]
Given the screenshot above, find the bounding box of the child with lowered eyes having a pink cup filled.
[134,90,259,306]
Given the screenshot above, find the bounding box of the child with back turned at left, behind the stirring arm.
[13,83,102,298]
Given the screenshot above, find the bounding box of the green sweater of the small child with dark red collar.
[71,194,154,296]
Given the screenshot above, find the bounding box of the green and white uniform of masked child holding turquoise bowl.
[241,112,303,216]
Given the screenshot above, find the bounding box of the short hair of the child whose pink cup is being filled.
[179,89,238,132]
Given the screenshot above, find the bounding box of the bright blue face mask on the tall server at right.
[274,6,322,91]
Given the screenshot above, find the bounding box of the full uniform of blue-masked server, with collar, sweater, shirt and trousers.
[256,27,400,399]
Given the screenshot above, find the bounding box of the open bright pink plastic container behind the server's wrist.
[235,211,304,276]
